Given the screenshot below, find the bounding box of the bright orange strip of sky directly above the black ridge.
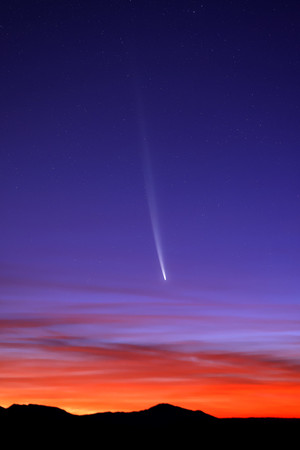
[0,385,300,418]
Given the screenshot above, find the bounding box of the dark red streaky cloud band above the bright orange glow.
[2,335,300,383]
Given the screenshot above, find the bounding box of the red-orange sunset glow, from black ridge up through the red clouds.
[0,346,300,418]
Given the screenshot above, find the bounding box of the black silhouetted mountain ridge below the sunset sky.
[0,404,300,448]
